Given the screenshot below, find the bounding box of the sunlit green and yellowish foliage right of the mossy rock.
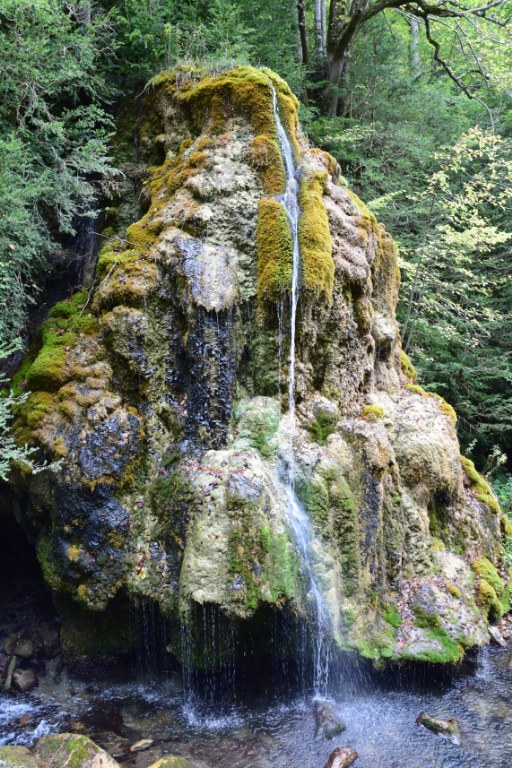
[306,12,512,462]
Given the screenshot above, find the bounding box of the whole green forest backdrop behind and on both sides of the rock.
[0,0,512,524]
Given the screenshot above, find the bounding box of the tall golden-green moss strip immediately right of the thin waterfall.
[299,171,334,301]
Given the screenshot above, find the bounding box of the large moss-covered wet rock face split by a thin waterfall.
[10,67,509,661]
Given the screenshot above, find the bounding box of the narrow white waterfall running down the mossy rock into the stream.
[270,83,330,694]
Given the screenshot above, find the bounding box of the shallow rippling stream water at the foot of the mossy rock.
[0,647,512,768]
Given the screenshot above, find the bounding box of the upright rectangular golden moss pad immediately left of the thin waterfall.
[256,197,293,301]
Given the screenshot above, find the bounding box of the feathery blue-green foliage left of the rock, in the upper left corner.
[0,0,113,352]
